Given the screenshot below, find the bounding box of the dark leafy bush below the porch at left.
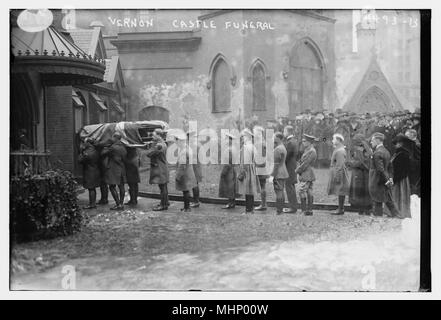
[10,170,84,241]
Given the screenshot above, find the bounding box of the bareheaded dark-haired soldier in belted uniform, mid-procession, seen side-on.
[271,132,289,214]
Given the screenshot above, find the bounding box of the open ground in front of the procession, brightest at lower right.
[11,194,419,291]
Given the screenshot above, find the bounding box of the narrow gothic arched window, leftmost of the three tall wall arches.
[211,57,231,112]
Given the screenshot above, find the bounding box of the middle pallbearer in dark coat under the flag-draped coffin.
[101,132,127,210]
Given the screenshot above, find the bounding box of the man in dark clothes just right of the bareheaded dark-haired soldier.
[283,126,298,213]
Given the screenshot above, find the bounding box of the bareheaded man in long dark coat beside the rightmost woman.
[369,132,401,218]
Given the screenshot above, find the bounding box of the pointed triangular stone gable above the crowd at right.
[343,54,403,112]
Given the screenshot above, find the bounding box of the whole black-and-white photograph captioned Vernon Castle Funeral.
[4,3,437,298]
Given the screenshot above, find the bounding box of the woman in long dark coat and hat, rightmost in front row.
[391,133,412,218]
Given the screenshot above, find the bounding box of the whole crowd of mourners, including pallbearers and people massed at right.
[79,110,421,218]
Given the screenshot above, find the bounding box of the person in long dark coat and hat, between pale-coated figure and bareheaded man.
[346,134,372,215]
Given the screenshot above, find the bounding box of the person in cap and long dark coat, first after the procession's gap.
[219,133,240,209]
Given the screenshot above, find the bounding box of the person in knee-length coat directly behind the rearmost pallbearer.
[175,133,197,212]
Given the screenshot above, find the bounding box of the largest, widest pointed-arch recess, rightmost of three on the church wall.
[288,39,324,115]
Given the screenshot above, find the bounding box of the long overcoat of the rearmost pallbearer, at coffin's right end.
[146,141,169,184]
